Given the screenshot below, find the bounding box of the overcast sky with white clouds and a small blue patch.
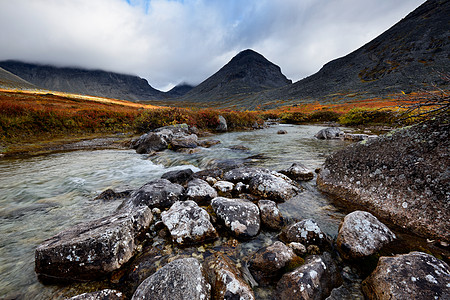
[0,0,424,90]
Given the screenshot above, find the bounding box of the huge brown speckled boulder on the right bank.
[317,118,450,242]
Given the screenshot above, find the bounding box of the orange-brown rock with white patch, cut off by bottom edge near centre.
[203,253,255,300]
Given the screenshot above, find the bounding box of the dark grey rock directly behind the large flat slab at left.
[129,179,184,208]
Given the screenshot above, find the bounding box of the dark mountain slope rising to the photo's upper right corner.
[255,0,450,102]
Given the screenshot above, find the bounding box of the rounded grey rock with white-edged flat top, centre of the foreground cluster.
[211,197,261,238]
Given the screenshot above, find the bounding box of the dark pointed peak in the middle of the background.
[181,49,292,101]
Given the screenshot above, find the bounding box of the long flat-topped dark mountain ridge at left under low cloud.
[0,60,166,101]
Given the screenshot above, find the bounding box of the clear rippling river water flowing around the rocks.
[0,125,347,299]
